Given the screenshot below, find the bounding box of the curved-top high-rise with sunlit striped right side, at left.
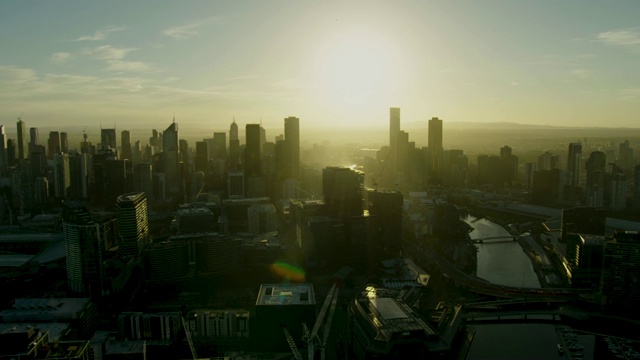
[116,193,149,256]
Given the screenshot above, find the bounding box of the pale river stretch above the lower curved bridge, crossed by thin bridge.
[462,215,540,288]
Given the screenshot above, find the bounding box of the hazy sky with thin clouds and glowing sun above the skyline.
[0,0,640,132]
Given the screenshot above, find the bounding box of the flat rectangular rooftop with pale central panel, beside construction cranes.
[256,284,316,305]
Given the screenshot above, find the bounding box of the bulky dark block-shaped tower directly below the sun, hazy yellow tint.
[322,167,364,219]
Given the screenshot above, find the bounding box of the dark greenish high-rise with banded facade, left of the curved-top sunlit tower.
[62,201,116,298]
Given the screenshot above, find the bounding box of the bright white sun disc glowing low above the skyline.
[316,30,399,108]
